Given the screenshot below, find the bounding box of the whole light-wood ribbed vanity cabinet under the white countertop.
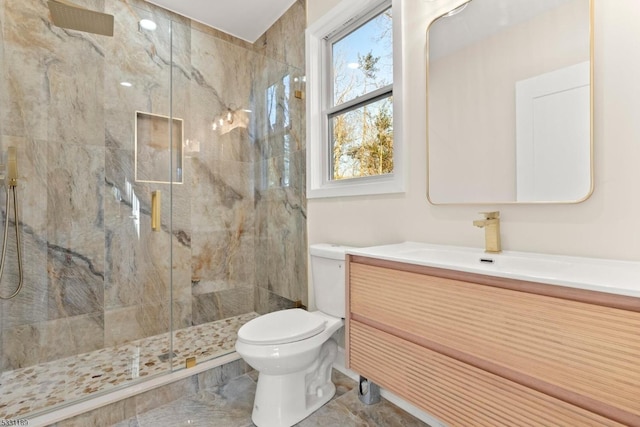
[345,255,640,427]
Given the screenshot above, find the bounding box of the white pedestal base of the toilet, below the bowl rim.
[251,339,337,427]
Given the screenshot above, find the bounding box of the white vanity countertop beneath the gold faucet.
[348,242,640,297]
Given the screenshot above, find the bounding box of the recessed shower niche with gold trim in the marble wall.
[135,111,184,184]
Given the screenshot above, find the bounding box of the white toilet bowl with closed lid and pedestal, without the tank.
[236,308,344,427]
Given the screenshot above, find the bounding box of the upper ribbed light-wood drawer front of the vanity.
[349,262,640,422]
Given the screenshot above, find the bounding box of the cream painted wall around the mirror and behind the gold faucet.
[307,0,640,303]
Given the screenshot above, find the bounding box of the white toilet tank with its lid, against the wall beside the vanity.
[309,243,350,317]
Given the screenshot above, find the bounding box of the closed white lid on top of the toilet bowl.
[238,308,327,345]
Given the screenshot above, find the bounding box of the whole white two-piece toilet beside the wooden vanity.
[236,244,347,427]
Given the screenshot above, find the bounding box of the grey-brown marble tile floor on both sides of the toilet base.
[112,370,428,427]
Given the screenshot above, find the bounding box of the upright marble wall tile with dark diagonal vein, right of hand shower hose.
[47,142,104,319]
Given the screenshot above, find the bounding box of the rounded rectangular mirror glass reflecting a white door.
[427,0,592,204]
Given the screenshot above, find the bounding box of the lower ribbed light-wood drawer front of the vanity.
[349,321,621,427]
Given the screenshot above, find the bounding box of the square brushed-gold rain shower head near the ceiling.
[48,0,113,36]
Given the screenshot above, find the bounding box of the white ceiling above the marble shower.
[147,0,296,43]
